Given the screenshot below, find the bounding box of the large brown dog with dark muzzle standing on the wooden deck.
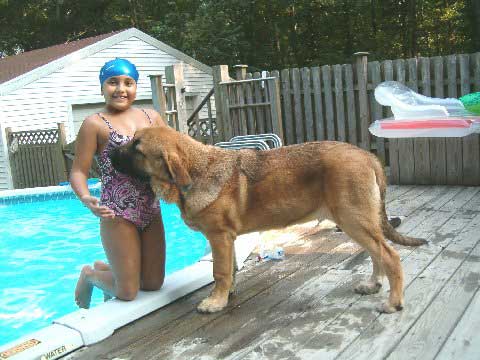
[112,127,425,313]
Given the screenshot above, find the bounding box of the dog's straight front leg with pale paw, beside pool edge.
[197,232,235,313]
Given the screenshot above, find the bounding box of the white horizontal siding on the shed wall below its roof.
[0,37,213,190]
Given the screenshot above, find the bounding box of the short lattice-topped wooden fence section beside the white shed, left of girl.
[5,124,67,189]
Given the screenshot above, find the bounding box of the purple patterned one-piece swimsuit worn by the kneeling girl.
[97,109,160,230]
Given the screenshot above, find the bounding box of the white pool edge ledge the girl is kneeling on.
[0,233,260,360]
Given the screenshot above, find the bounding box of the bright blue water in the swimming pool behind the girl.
[0,191,207,345]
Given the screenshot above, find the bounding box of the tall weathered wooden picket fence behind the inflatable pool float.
[217,53,480,185]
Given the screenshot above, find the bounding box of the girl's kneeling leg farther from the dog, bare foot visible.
[75,217,142,308]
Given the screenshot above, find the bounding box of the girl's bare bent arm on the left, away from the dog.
[70,117,114,217]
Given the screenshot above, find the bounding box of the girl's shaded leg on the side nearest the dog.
[140,215,165,291]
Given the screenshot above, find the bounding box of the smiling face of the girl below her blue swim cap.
[102,75,137,111]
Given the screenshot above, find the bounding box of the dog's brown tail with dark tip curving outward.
[374,159,427,246]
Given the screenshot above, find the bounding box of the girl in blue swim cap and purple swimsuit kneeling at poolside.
[70,58,165,308]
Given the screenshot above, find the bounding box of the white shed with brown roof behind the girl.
[0,28,213,190]
